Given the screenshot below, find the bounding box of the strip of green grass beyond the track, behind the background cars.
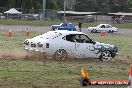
[0,19,132,29]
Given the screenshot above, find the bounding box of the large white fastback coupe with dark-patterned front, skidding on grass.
[24,30,118,61]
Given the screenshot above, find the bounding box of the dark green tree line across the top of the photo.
[0,0,132,13]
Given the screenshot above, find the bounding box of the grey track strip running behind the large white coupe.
[0,25,132,35]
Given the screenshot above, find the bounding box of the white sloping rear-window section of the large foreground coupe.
[33,31,62,39]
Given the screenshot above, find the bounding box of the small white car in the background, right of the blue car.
[88,24,118,33]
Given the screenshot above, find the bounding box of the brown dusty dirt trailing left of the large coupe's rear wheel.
[0,50,51,61]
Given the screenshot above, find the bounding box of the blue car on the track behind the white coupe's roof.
[51,23,76,31]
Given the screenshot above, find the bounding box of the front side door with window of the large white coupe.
[74,34,96,58]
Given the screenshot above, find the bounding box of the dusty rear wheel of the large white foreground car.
[53,49,67,61]
